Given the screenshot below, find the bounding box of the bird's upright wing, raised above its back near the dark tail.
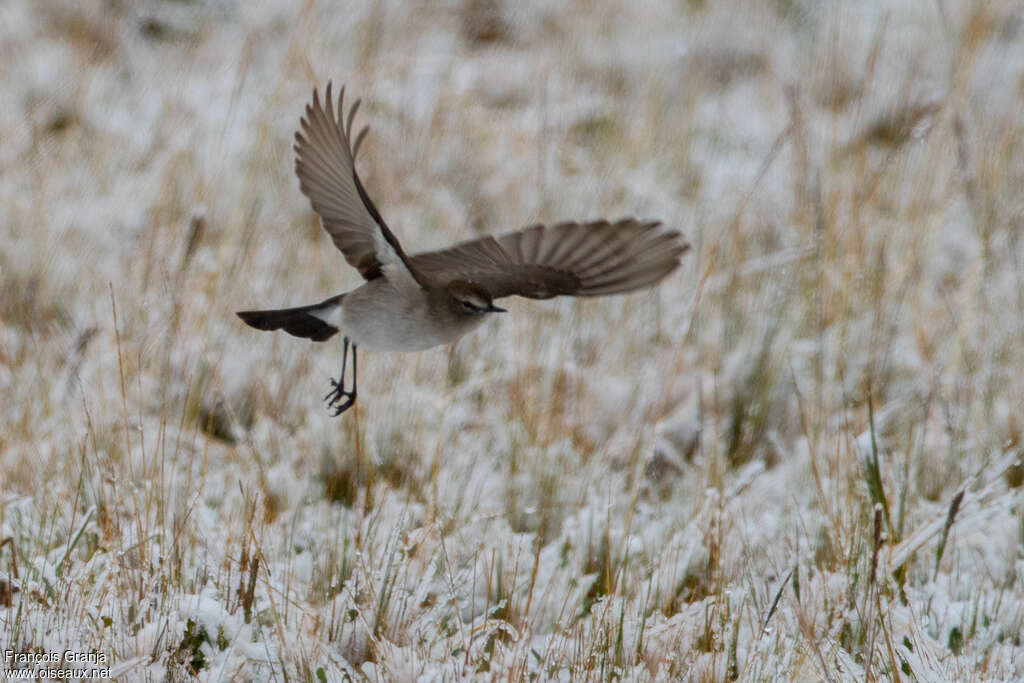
[295,83,419,286]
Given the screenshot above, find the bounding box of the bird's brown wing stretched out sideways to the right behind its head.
[410,218,690,299]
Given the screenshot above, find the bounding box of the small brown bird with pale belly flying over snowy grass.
[238,83,690,416]
